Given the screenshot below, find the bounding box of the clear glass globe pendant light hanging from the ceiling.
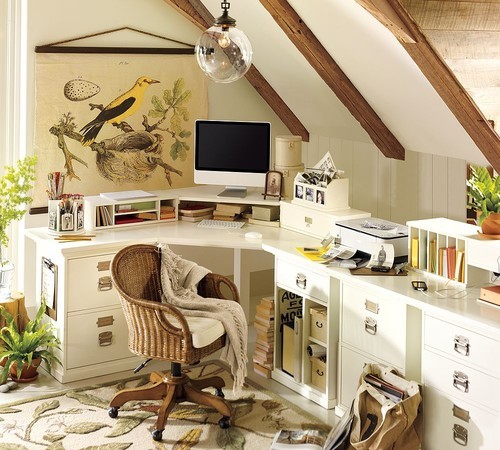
[195,0,252,83]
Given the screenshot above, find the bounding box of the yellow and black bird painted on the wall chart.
[80,77,159,146]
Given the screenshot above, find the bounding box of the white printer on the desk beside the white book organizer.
[335,217,408,262]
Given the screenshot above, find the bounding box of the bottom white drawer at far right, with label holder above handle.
[423,386,500,450]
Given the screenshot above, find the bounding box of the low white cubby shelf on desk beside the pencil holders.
[84,191,179,230]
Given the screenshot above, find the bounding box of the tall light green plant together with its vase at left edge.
[0,156,37,302]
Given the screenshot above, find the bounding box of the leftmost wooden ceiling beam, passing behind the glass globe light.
[164,0,309,142]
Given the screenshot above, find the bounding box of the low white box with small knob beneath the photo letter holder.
[280,201,370,239]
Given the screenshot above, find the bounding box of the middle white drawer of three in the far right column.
[422,349,500,411]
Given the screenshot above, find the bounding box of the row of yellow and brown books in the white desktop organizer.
[411,238,465,283]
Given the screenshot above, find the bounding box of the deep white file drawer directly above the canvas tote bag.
[342,284,406,367]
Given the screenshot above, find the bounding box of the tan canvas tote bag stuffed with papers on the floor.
[349,364,423,450]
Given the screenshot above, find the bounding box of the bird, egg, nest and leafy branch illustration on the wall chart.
[49,76,192,186]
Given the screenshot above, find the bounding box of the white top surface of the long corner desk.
[26,221,500,339]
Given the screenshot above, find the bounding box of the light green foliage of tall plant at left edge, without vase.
[0,156,37,250]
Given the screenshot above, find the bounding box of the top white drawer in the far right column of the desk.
[424,315,500,376]
